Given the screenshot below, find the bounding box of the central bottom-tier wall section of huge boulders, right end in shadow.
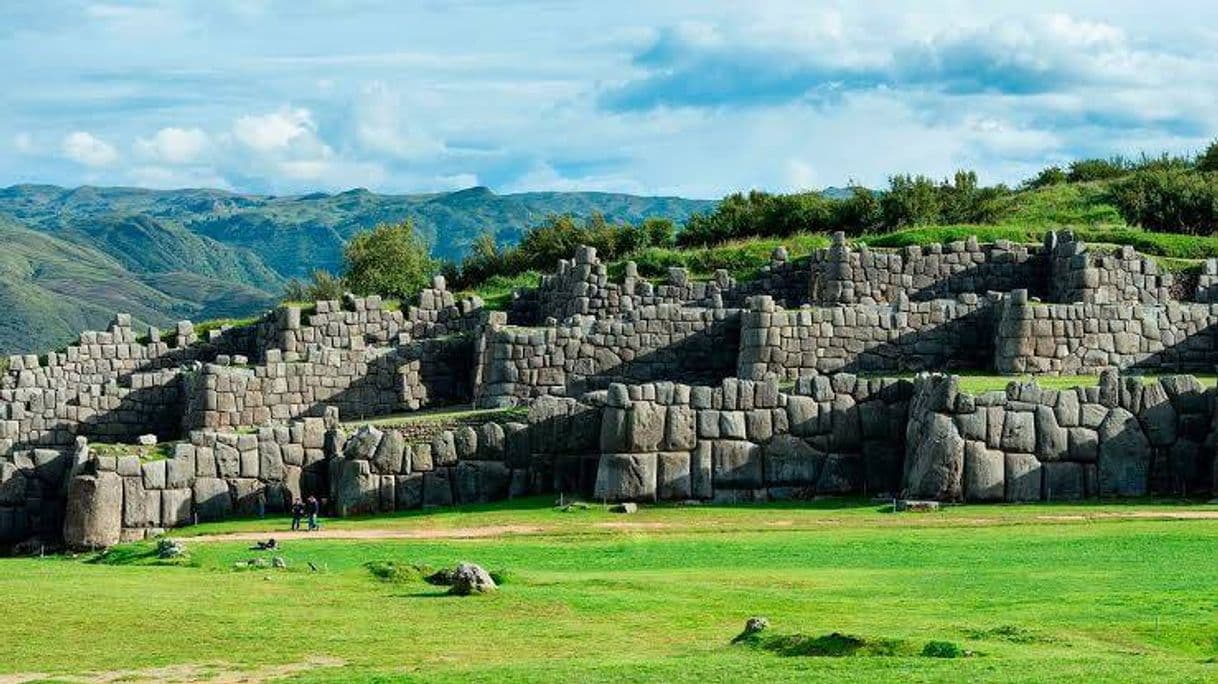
[594,374,912,503]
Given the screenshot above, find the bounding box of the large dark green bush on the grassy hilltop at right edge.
[1112,170,1218,235]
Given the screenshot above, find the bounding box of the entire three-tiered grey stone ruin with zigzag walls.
[0,232,1218,548]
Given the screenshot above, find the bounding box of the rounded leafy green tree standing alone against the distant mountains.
[342,220,436,299]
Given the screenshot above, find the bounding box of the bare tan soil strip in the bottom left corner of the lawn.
[0,657,346,684]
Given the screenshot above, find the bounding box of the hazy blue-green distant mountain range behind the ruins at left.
[0,185,715,354]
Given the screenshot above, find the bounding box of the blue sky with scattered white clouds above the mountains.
[0,0,1218,198]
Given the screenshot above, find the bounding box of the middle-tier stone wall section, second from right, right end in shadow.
[737,295,996,379]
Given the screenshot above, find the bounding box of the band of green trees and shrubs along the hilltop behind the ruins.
[286,142,1218,299]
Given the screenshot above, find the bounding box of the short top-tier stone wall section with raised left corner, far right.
[1047,231,1174,304]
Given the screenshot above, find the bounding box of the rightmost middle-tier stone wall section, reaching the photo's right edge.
[994,291,1218,374]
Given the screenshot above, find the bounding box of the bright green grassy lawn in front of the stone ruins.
[7,499,1218,682]
